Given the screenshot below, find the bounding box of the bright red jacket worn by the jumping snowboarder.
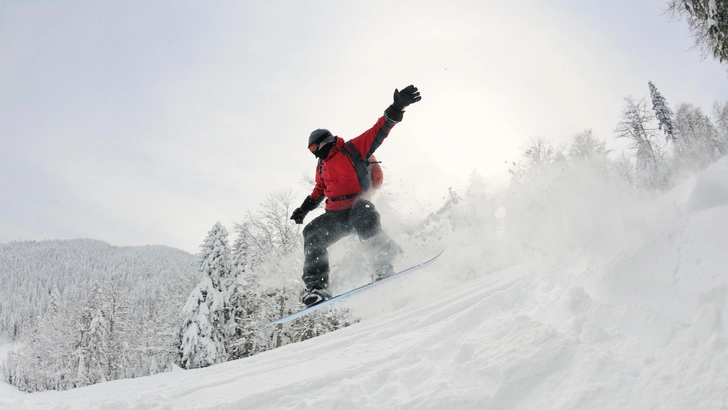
[311,116,396,211]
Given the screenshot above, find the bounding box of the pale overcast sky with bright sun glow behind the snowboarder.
[0,0,728,252]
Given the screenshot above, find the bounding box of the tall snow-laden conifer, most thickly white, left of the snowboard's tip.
[179,222,233,369]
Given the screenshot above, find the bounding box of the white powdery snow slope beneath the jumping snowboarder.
[0,158,728,410]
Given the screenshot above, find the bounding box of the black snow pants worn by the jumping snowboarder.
[303,200,382,290]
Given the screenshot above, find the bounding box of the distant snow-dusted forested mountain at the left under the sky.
[0,239,197,337]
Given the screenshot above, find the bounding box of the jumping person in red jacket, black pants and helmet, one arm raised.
[291,85,421,306]
